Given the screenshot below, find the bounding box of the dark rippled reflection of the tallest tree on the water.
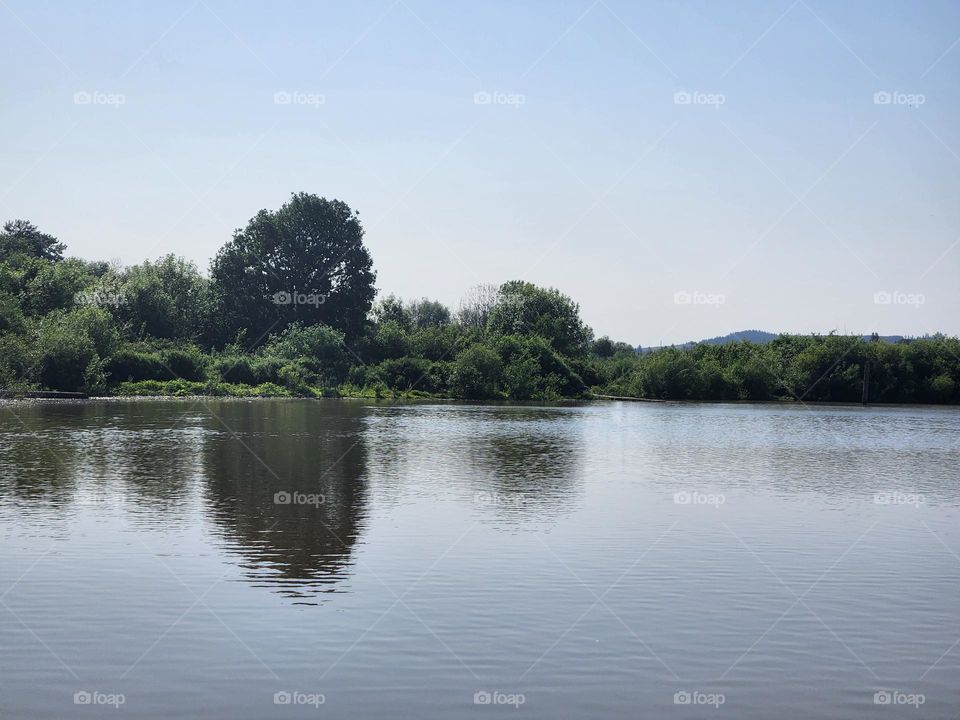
[202,402,367,597]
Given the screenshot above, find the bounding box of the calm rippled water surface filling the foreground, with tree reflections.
[0,400,960,720]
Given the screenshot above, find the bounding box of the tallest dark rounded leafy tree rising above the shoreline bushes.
[211,193,376,343]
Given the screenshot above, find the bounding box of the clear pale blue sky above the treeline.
[0,0,960,346]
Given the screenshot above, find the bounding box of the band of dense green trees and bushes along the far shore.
[0,193,960,403]
